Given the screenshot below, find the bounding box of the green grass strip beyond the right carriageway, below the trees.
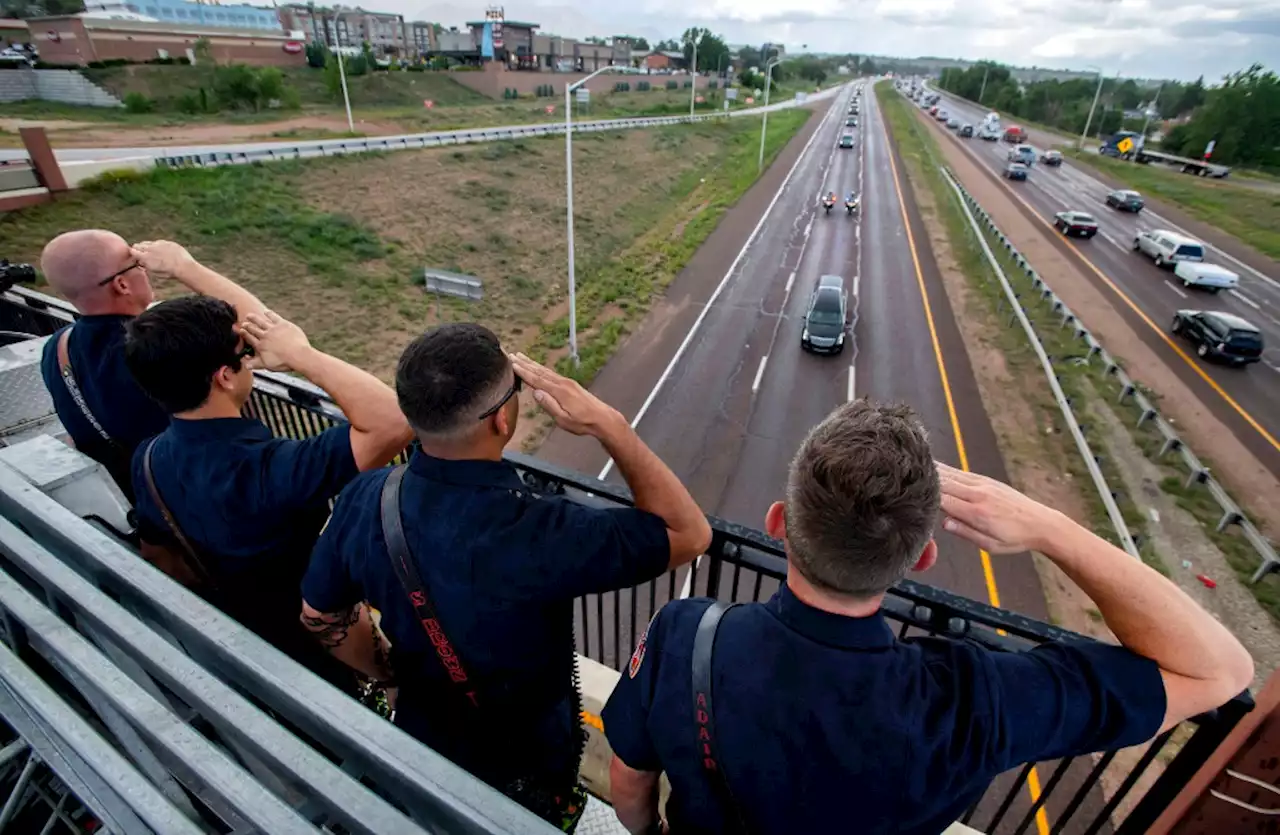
[1066,150,1280,259]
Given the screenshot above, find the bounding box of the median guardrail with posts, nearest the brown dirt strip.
[946,163,1280,583]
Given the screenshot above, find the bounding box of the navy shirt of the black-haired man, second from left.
[133,418,358,684]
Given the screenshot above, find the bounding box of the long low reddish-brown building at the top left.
[28,15,306,67]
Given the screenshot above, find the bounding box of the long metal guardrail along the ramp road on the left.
[147,86,844,168]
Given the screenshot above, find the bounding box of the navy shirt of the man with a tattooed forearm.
[302,452,671,789]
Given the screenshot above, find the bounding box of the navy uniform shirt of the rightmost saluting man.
[603,587,1165,835]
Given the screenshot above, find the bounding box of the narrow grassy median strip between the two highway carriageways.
[877,81,1280,622]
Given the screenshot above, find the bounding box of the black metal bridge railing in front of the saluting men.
[0,284,1253,835]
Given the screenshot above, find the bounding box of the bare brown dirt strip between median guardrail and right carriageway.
[916,117,1280,534]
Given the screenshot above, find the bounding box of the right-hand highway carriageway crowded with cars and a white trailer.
[933,90,1280,474]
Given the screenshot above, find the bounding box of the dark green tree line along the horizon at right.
[940,61,1280,169]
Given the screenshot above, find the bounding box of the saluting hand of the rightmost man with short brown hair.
[938,462,1064,553]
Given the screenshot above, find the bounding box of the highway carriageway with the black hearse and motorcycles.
[539,86,1047,647]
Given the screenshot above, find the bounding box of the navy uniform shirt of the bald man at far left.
[40,316,169,502]
